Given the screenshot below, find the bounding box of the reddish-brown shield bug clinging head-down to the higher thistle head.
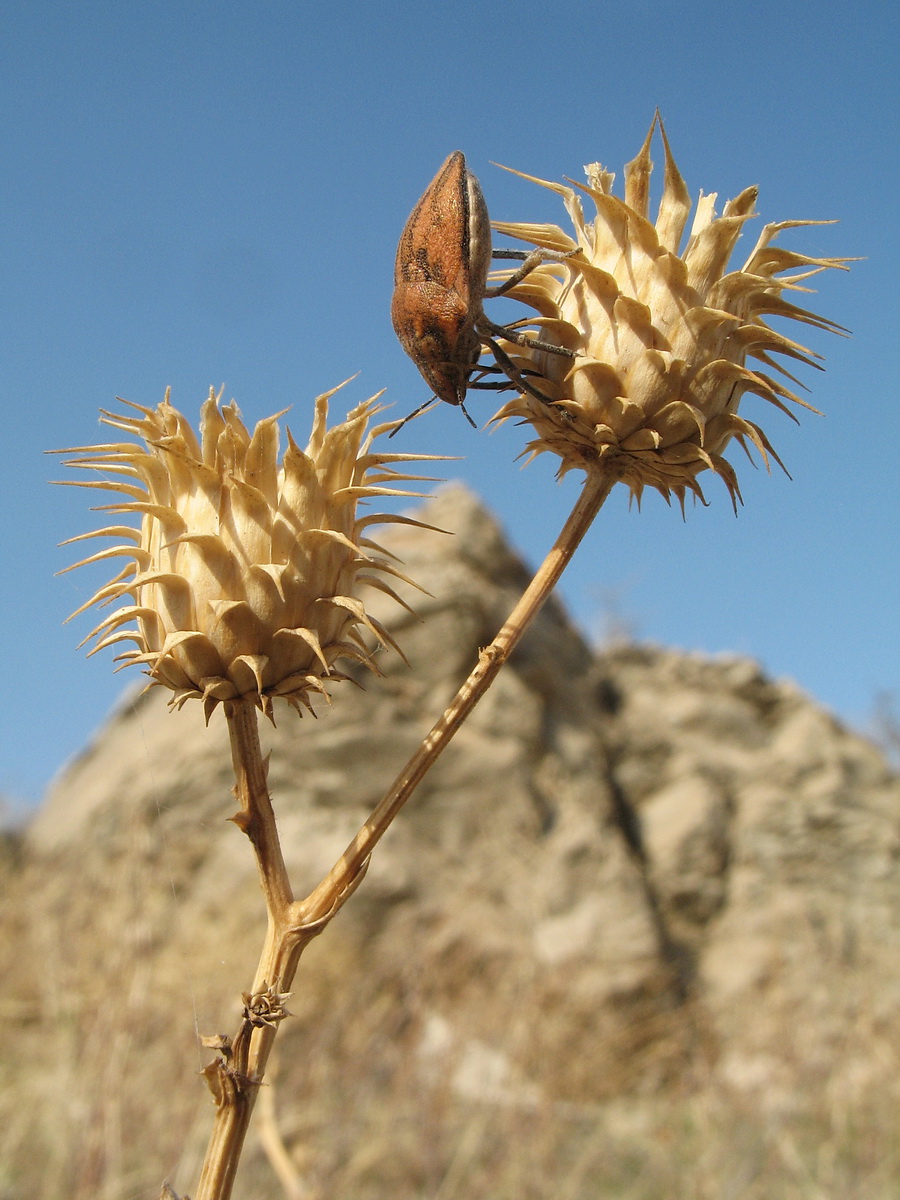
[391,150,575,432]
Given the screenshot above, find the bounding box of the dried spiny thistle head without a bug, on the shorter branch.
[55,389,436,718]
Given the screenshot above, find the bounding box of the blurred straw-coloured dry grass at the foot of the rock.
[0,811,900,1200]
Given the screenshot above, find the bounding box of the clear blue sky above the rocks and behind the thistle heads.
[0,0,900,800]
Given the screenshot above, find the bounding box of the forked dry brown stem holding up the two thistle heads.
[187,472,616,1200]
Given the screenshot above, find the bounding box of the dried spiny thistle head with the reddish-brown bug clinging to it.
[494,118,848,505]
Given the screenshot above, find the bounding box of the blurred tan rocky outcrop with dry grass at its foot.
[0,488,900,1200]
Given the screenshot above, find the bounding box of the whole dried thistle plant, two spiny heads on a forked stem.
[56,131,847,1200]
